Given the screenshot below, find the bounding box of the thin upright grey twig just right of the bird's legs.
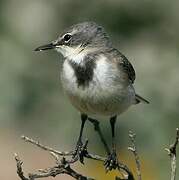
[128,131,142,180]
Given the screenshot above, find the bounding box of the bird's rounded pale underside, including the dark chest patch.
[61,57,135,114]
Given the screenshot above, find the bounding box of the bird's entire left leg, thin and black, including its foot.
[73,114,88,163]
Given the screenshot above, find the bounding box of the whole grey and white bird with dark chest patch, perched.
[35,22,149,170]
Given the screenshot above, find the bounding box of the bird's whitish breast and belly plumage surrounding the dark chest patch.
[61,59,135,116]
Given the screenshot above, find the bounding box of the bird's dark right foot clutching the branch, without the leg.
[104,151,119,172]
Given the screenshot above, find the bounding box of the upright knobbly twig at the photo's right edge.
[165,128,179,180]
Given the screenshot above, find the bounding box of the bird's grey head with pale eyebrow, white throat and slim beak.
[35,22,111,57]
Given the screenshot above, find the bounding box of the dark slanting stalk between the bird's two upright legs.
[88,118,110,155]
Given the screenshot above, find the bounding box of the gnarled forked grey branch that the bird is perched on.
[15,136,134,180]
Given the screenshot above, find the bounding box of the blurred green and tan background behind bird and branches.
[0,0,179,180]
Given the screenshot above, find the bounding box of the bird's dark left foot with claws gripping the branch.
[73,140,88,164]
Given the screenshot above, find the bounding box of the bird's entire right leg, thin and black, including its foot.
[104,116,118,171]
